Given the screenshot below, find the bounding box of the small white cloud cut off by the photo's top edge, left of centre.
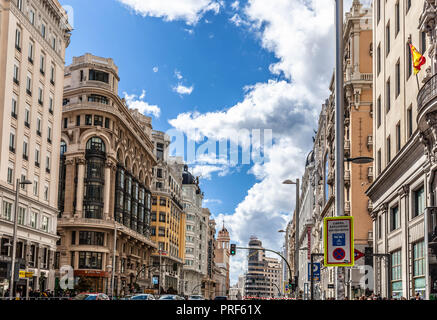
[118,0,224,25]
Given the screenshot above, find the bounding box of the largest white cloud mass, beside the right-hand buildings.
[169,0,370,282]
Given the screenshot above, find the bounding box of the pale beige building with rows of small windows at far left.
[0,0,71,296]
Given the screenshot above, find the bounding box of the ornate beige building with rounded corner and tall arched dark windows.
[56,54,157,294]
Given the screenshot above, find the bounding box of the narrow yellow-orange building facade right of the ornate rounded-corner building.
[151,131,186,293]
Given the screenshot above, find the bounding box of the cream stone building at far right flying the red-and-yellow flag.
[367,0,437,298]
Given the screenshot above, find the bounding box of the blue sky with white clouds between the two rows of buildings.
[60,0,370,284]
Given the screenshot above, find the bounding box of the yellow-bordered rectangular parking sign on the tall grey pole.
[323,216,355,267]
